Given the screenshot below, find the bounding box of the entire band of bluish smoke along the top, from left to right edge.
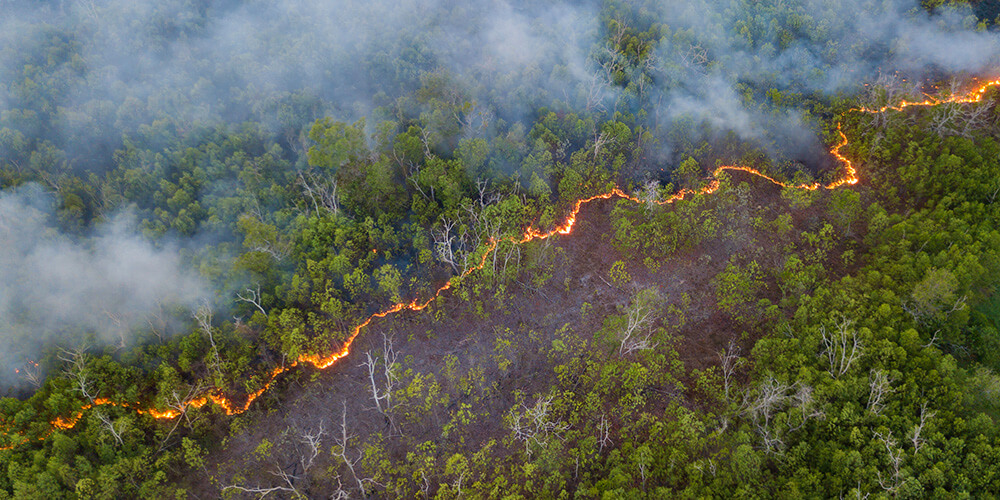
[0,0,1000,167]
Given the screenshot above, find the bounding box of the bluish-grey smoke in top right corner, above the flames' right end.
[651,0,1000,160]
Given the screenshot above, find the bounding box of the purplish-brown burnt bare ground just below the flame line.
[203,178,796,491]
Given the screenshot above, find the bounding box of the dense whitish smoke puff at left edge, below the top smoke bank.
[0,186,209,385]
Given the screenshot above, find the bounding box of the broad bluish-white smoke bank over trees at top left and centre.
[0,0,600,159]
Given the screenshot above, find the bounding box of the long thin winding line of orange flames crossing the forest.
[0,79,1000,450]
